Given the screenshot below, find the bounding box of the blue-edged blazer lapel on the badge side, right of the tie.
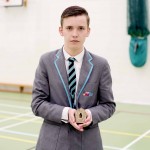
[76,50,94,100]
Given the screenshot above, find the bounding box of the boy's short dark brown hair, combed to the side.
[60,6,90,26]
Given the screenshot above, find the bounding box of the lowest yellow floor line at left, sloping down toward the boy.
[0,135,36,144]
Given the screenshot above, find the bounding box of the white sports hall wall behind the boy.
[0,0,150,104]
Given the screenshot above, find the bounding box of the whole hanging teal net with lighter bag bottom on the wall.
[128,0,150,67]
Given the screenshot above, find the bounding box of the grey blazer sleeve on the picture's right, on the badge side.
[89,61,116,125]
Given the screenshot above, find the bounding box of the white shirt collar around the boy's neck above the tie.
[63,48,85,63]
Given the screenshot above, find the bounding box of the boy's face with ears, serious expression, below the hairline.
[59,15,90,50]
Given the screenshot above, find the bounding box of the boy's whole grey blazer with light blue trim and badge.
[31,49,115,150]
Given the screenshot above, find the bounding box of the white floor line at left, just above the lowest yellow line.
[0,130,38,137]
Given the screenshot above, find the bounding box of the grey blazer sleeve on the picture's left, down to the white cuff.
[31,56,64,123]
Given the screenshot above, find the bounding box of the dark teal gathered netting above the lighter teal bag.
[128,0,149,37]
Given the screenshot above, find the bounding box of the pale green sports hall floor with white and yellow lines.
[0,92,150,150]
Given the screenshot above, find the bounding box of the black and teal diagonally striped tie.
[68,57,76,106]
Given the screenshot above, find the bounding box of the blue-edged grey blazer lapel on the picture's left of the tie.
[54,49,72,107]
